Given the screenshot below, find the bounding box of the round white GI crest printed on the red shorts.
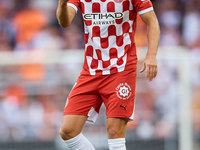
[116,83,132,100]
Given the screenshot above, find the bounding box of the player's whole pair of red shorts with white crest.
[63,69,137,123]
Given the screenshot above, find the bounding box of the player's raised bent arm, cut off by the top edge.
[56,0,76,28]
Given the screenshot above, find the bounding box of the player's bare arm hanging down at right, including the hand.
[140,10,160,81]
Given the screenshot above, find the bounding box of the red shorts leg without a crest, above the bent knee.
[63,75,102,116]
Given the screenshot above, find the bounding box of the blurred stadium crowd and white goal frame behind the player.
[0,0,200,150]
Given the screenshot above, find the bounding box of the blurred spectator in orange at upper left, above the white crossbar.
[13,3,48,50]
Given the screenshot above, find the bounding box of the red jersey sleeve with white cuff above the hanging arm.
[132,0,153,15]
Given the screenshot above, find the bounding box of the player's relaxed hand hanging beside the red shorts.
[140,56,158,81]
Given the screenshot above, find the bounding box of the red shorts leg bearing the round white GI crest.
[100,69,136,120]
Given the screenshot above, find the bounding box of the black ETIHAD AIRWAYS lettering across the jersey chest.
[83,12,124,25]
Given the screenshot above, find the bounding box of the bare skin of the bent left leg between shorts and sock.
[60,115,87,140]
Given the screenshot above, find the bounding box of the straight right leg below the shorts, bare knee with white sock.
[106,118,128,150]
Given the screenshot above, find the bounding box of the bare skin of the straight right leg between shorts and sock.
[106,118,129,139]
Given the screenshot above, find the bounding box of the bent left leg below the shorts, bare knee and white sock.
[60,115,95,150]
